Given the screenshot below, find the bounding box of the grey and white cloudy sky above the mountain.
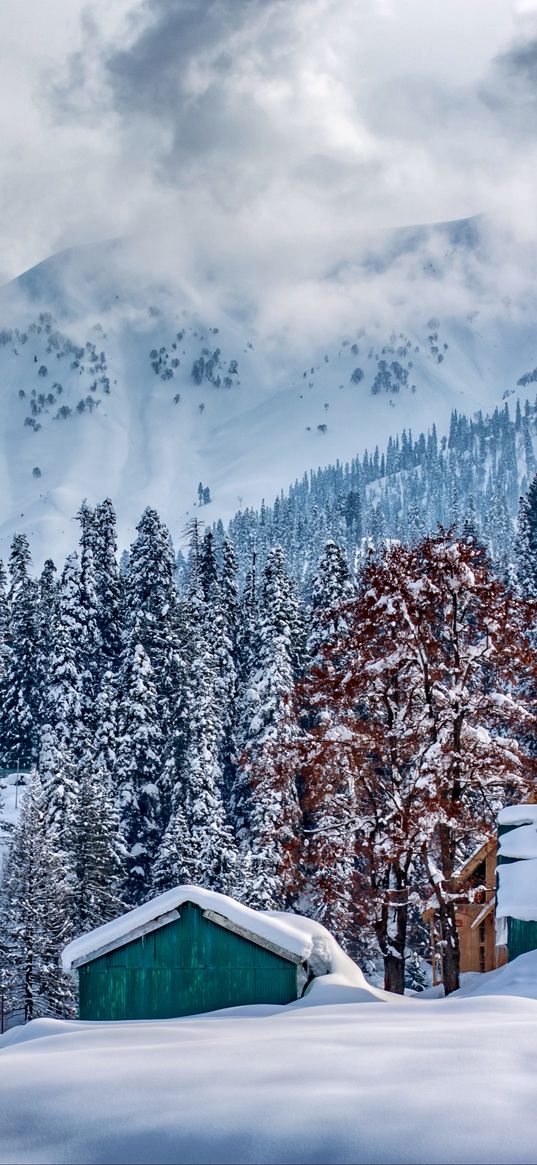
[0,0,537,293]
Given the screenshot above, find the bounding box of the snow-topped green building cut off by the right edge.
[496,803,537,962]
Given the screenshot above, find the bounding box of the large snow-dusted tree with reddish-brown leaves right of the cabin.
[284,531,535,993]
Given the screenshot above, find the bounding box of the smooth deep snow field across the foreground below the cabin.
[0,953,537,1163]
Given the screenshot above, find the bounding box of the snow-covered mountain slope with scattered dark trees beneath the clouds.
[0,220,537,563]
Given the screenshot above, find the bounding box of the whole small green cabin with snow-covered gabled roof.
[63,885,313,1021]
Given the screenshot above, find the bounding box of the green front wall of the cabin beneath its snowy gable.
[78,902,297,1019]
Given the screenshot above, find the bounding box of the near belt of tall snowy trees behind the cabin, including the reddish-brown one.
[0,480,537,1018]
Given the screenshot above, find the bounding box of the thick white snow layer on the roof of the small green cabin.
[62,885,365,986]
